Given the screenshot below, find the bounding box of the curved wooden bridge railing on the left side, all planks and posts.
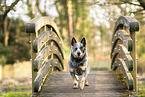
[26,17,64,94]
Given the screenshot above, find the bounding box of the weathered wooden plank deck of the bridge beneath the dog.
[38,71,137,97]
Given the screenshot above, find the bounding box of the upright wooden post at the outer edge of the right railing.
[130,32,137,92]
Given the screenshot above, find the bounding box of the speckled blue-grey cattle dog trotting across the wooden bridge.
[68,37,89,89]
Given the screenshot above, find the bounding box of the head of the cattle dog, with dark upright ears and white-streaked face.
[71,37,86,59]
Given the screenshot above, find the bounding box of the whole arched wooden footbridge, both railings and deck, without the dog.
[26,16,139,97]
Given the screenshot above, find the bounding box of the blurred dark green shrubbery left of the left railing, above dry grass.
[0,19,30,65]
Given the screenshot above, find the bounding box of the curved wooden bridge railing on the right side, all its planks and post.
[111,16,139,90]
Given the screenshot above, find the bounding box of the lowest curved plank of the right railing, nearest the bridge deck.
[112,58,134,90]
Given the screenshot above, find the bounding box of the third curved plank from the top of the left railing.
[33,45,64,71]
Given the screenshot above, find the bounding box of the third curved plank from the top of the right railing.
[111,44,133,71]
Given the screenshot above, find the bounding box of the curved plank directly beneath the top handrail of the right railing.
[111,30,133,58]
